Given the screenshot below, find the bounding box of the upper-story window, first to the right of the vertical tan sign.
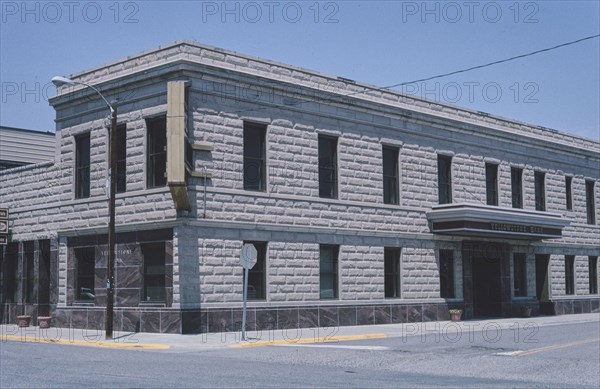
[244,123,267,192]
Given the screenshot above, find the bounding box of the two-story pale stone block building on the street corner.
[0,41,600,333]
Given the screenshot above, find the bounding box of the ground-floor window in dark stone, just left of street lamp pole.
[73,246,96,303]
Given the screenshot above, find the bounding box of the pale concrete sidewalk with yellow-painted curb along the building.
[0,313,600,352]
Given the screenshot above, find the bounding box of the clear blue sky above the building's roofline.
[0,0,600,140]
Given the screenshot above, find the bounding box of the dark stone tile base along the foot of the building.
[3,298,600,334]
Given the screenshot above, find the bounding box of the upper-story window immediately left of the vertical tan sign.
[146,116,167,188]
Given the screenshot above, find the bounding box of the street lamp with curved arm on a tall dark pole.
[52,76,117,340]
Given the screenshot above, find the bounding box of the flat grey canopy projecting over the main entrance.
[427,204,569,240]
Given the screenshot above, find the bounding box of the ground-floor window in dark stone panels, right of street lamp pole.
[141,242,165,303]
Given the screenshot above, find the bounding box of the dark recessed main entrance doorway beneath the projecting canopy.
[473,256,502,316]
